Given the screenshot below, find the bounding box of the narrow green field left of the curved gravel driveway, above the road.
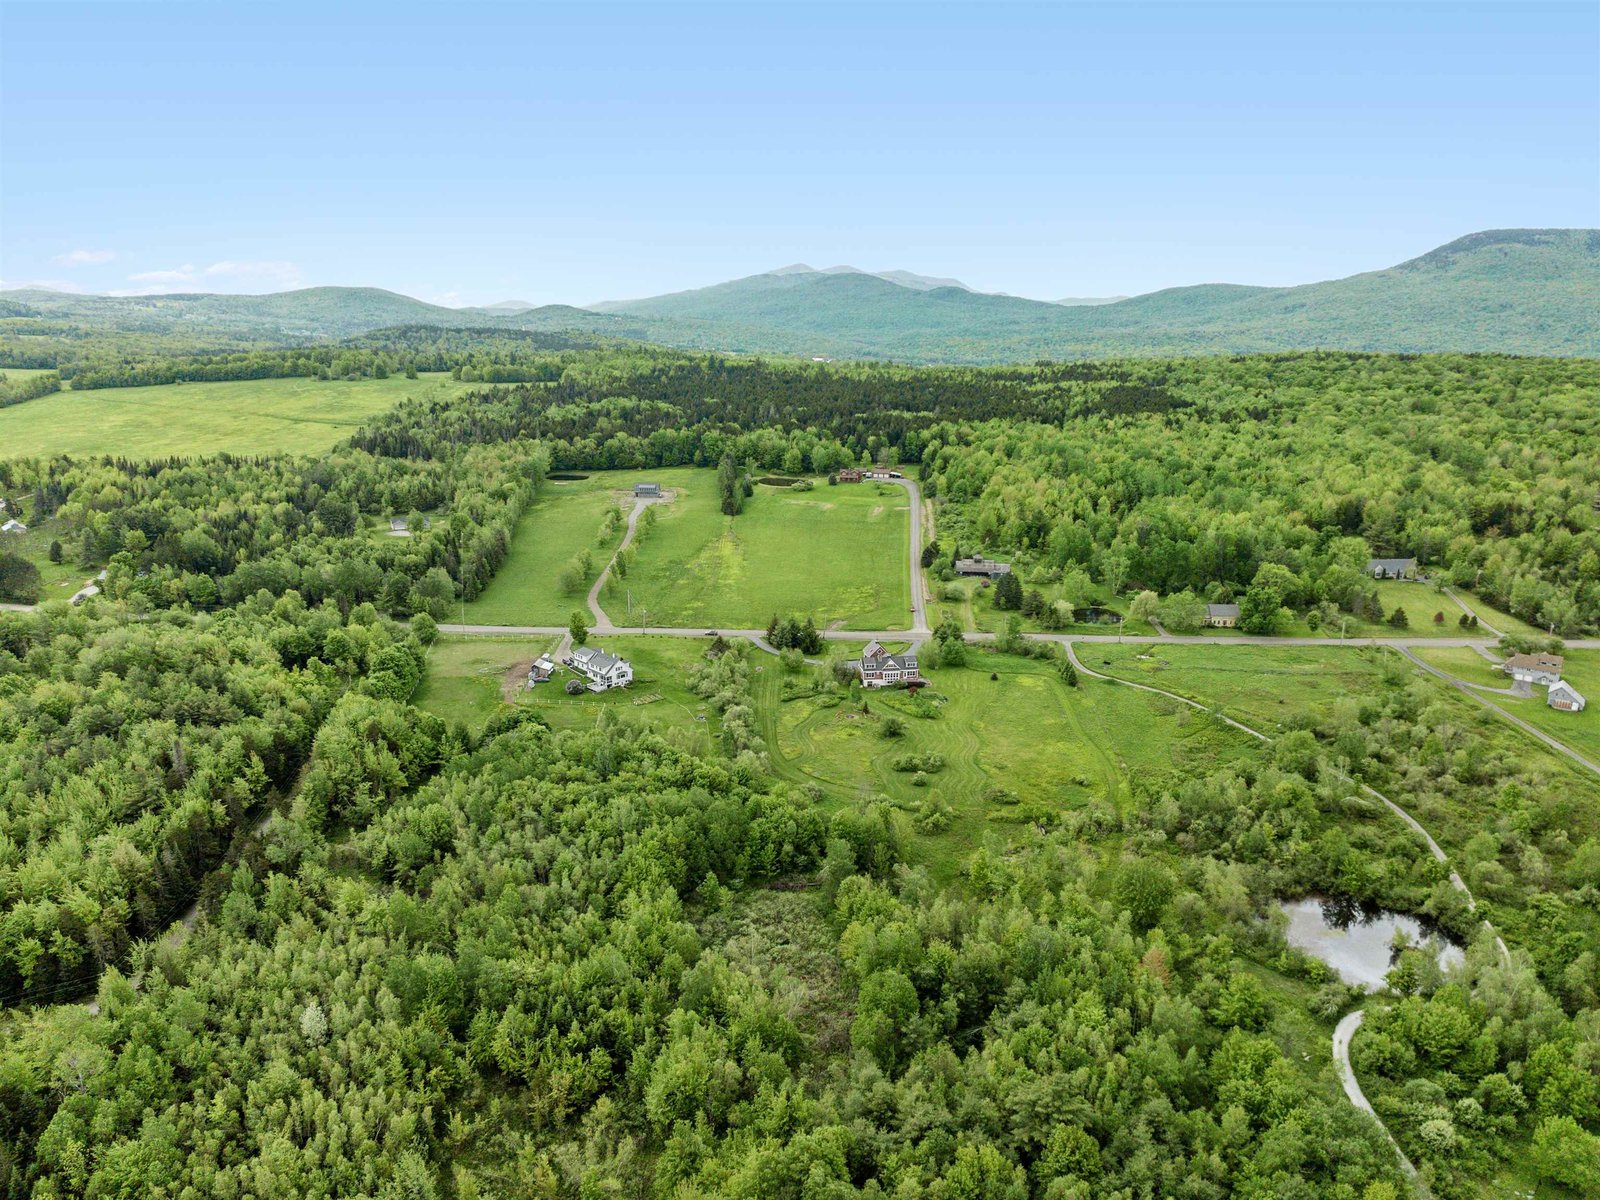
[466,470,633,626]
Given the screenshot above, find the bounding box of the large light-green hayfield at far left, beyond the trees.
[0,374,470,458]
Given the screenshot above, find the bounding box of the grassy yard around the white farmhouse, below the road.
[413,635,720,754]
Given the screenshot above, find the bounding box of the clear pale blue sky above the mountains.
[0,0,1600,304]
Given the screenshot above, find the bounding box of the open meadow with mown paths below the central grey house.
[758,653,1253,877]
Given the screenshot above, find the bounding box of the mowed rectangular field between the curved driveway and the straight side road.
[620,470,910,629]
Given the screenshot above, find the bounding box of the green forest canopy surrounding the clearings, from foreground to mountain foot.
[0,340,1600,1200]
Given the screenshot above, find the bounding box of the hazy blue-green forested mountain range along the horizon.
[0,229,1600,363]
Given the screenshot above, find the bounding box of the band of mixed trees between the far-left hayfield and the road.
[0,445,549,618]
